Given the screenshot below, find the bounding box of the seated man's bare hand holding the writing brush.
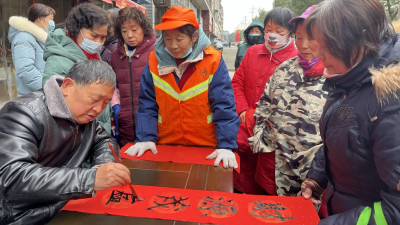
[94,162,131,191]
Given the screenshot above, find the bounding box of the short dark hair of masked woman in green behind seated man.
[65,3,110,38]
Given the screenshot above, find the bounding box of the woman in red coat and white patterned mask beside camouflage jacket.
[232,7,297,194]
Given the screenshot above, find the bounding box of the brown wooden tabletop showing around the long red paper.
[48,159,233,225]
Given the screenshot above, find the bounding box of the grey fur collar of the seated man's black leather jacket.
[43,75,75,122]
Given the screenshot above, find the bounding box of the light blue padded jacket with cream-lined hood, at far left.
[8,16,47,97]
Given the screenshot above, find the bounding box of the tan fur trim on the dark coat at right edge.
[370,63,400,105]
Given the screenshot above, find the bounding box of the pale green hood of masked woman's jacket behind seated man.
[43,29,87,62]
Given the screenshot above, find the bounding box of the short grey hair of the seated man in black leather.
[66,59,117,88]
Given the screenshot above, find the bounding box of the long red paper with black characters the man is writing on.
[62,185,319,225]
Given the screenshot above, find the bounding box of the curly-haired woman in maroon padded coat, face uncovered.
[110,7,156,146]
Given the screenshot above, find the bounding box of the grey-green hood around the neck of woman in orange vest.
[155,28,211,71]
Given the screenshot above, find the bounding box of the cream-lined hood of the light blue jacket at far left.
[8,16,47,44]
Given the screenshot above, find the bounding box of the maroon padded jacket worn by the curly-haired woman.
[110,35,156,146]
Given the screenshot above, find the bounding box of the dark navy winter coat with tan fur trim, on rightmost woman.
[307,34,400,224]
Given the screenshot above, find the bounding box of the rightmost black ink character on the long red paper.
[250,200,294,222]
